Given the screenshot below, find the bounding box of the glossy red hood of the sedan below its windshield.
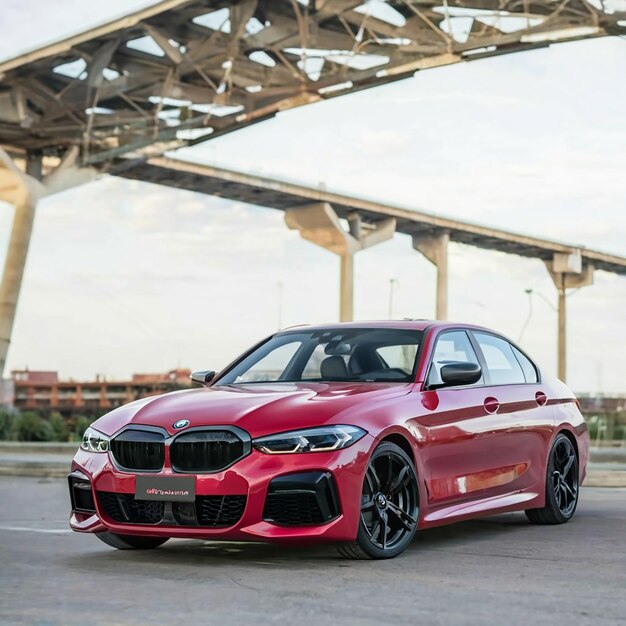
[93,383,411,437]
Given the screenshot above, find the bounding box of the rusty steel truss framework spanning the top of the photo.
[0,0,626,161]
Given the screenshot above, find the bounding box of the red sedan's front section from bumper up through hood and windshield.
[69,327,421,548]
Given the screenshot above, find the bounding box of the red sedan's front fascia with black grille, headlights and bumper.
[69,420,374,541]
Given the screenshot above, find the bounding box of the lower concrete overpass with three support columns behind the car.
[112,157,626,380]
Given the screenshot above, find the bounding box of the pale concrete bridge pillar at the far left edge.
[0,150,43,378]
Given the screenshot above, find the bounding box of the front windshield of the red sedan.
[217,328,422,385]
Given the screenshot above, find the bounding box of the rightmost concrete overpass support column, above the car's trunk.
[545,250,594,382]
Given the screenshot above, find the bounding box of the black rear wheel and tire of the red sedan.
[526,433,579,525]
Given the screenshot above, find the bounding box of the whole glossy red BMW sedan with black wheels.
[69,321,589,559]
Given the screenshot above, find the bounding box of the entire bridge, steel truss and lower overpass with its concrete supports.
[0,0,626,378]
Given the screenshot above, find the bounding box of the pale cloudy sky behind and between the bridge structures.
[0,0,626,393]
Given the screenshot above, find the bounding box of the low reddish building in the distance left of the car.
[4,369,191,415]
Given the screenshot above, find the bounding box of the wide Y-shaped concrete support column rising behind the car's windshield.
[285,202,396,322]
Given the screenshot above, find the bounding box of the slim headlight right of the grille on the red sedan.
[252,426,367,454]
